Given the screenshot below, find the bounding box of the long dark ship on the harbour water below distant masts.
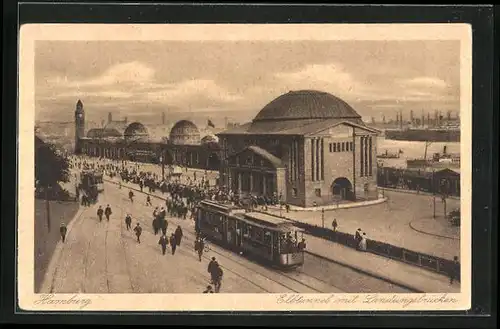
[385,127,460,142]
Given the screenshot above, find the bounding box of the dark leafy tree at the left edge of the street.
[35,136,70,232]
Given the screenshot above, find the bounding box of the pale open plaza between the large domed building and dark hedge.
[266,192,460,260]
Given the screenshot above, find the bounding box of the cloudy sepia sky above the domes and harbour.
[35,40,460,124]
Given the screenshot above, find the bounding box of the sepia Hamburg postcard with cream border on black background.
[17,24,472,311]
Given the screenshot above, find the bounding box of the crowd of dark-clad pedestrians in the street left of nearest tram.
[65,156,226,293]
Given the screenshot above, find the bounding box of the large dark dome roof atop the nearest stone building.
[253,90,361,122]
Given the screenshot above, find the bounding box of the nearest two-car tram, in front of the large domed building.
[196,200,304,269]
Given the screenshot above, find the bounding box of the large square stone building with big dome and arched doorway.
[217,90,379,207]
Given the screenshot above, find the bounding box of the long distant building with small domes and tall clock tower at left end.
[75,100,220,170]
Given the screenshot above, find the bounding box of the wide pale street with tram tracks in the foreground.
[44,178,409,293]
